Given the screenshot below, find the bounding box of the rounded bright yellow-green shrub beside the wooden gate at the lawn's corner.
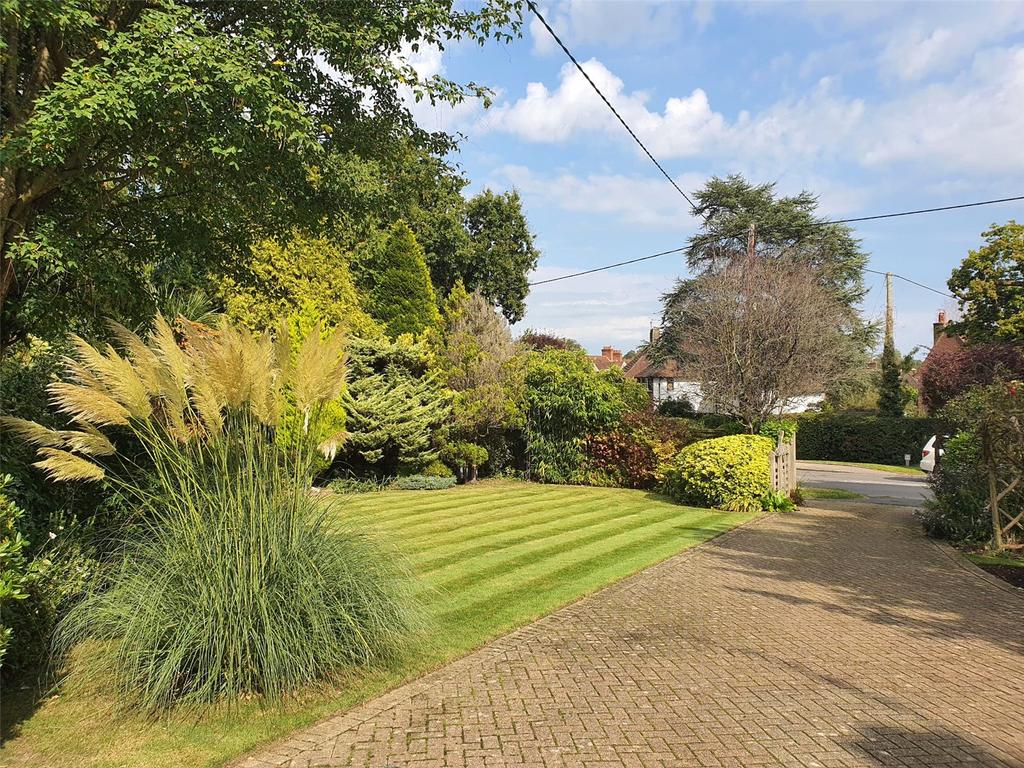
[665,435,774,511]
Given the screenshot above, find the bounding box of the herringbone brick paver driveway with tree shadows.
[240,505,1024,768]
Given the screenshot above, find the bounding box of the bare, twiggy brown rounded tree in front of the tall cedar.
[659,258,859,431]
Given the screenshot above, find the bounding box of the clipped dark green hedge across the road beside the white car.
[797,414,942,464]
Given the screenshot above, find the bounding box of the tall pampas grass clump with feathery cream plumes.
[6,316,413,712]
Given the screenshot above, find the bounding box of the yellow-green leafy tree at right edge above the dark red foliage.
[948,220,1024,342]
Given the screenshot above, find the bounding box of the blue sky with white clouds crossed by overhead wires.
[411,0,1024,353]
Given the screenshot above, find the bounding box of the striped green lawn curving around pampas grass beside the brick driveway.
[0,480,750,768]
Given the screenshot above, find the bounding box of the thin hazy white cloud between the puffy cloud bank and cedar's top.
[497,165,705,231]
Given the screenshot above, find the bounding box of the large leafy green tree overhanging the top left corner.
[0,0,520,343]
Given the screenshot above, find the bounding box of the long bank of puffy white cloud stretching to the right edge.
[478,46,1024,173]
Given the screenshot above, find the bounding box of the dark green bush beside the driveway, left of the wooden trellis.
[920,430,992,544]
